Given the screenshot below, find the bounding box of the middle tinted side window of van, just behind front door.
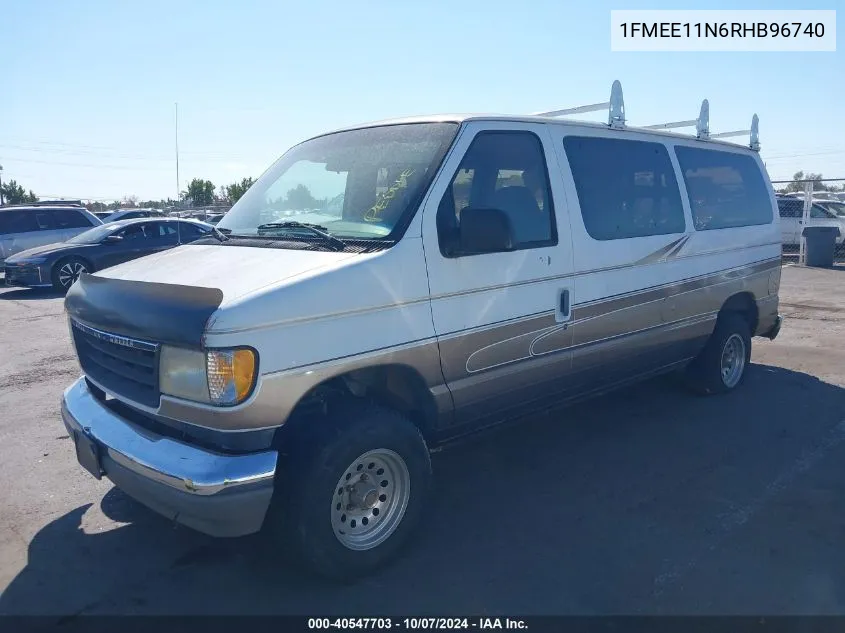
[563,136,686,240]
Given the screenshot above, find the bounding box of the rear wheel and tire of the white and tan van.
[686,312,751,395]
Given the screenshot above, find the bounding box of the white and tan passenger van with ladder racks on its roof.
[62,84,781,577]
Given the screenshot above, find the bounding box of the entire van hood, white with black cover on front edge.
[65,244,360,347]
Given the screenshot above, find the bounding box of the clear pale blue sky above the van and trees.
[0,0,845,199]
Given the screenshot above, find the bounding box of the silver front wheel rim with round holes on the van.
[331,448,411,551]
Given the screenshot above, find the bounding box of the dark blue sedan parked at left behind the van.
[5,218,214,291]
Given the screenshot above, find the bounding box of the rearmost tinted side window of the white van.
[675,145,773,231]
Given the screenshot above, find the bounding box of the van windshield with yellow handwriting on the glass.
[217,123,458,240]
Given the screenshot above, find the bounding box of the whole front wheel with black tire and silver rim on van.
[266,400,432,582]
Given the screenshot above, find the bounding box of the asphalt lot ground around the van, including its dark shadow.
[0,266,845,621]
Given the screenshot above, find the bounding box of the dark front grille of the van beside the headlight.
[71,319,160,407]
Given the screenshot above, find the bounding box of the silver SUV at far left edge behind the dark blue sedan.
[0,204,103,264]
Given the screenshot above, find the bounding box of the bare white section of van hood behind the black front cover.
[95,244,356,303]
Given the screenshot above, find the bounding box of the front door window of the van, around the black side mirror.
[437,131,557,257]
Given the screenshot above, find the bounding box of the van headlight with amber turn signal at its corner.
[159,345,258,406]
